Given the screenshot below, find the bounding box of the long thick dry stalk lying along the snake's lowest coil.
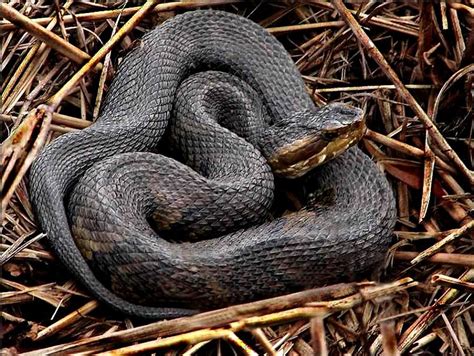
[20,278,416,355]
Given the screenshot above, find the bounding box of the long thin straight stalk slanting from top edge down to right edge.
[331,0,474,185]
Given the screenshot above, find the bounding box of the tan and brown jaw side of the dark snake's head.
[268,121,366,179]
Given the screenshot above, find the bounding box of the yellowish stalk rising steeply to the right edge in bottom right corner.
[398,268,474,353]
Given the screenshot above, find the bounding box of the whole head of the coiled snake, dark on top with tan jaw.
[263,103,365,178]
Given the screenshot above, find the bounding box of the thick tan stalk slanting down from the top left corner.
[0,4,102,70]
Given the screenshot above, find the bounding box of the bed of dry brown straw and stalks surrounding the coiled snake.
[0,0,474,355]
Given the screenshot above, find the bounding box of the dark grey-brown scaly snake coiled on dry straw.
[29,10,396,319]
